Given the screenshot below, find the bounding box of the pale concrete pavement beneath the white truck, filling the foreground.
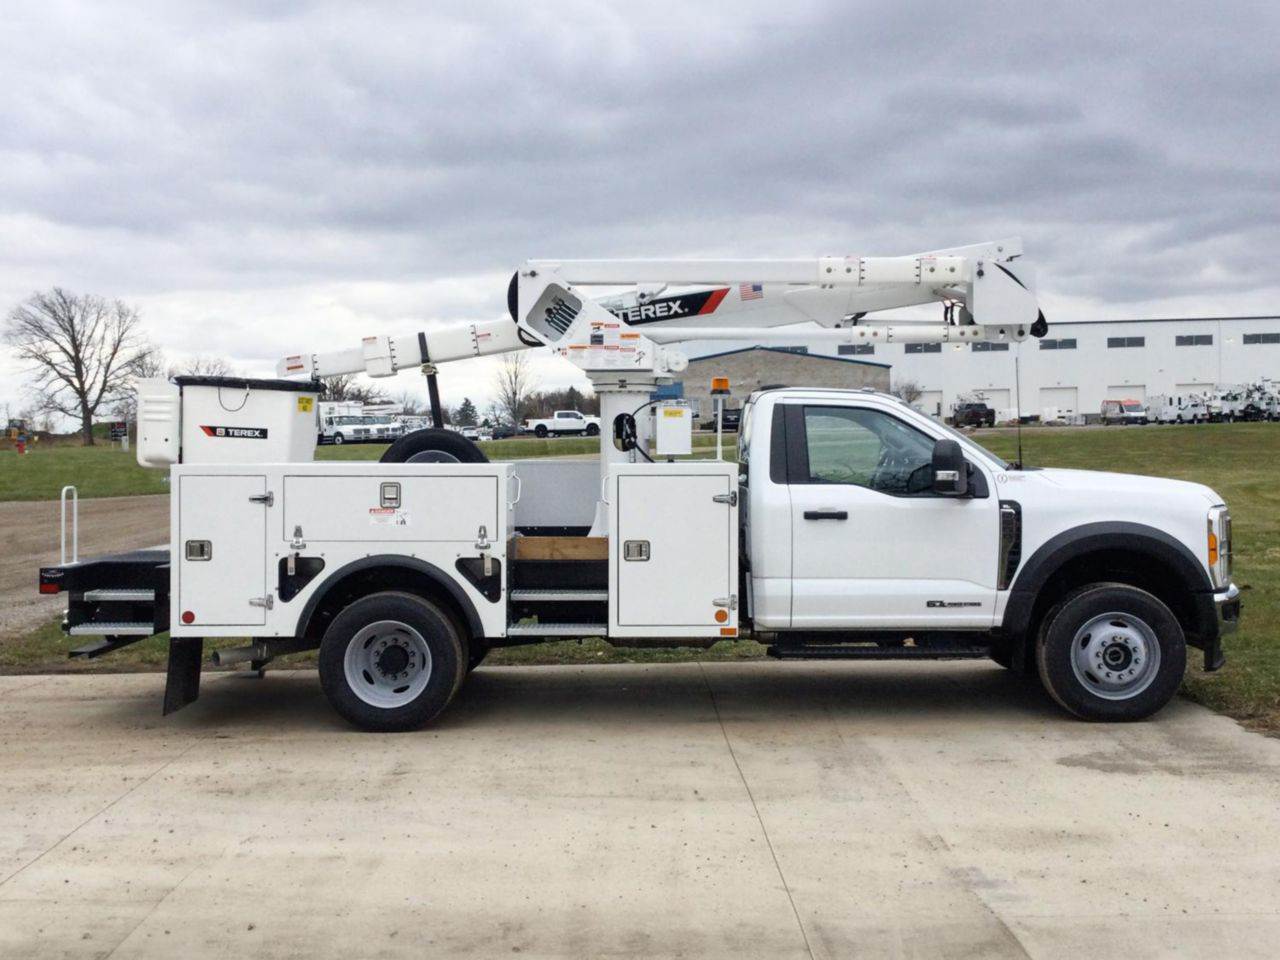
[0,662,1280,960]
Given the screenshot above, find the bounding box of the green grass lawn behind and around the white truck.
[0,424,1280,731]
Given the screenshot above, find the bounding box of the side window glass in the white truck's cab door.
[804,407,933,494]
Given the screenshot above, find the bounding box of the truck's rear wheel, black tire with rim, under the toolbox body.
[320,591,467,732]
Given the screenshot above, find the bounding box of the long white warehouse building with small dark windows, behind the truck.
[686,316,1280,419]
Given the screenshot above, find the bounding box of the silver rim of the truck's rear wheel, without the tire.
[343,620,433,709]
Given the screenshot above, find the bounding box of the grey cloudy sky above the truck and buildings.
[0,0,1280,419]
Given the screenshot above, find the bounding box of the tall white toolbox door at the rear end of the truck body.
[174,475,269,627]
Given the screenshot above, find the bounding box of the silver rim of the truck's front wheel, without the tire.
[1071,613,1160,700]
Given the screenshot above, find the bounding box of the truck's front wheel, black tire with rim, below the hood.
[1036,584,1187,722]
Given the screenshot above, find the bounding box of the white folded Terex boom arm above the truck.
[278,238,1047,376]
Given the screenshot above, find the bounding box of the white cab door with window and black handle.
[785,401,1000,630]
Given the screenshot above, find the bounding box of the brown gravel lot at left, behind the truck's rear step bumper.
[0,494,169,637]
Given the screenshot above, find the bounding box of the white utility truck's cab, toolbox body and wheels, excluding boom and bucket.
[40,388,1240,730]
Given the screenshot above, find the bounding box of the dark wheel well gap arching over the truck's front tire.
[1024,548,1197,663]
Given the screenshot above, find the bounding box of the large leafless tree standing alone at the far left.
[4,287,151,447]
